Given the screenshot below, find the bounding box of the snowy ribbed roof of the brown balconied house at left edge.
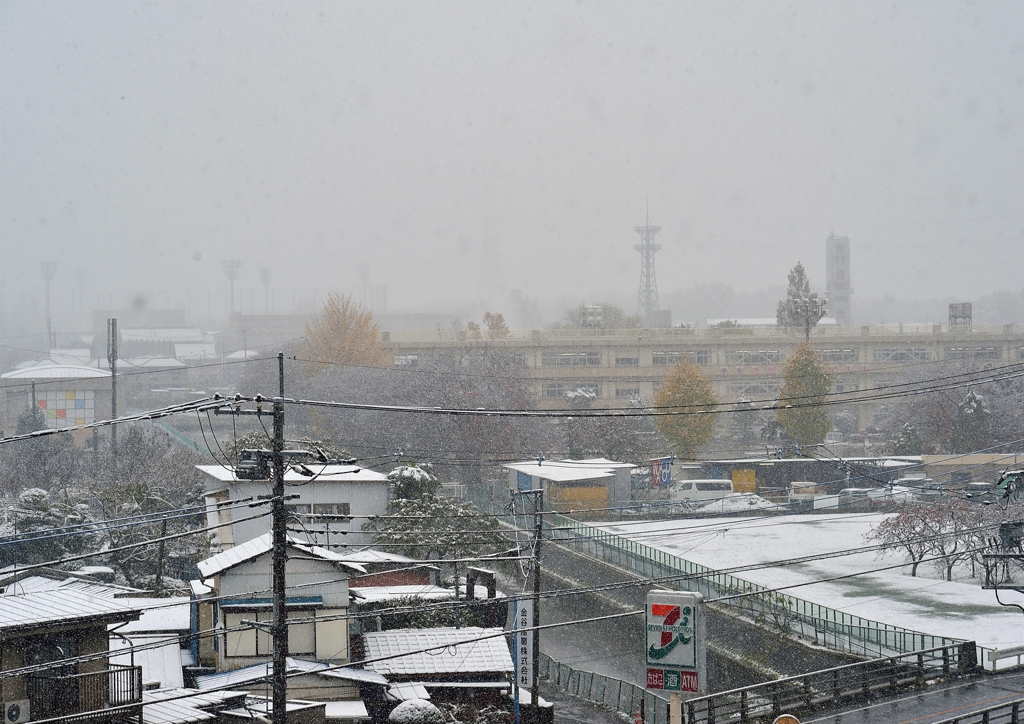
[0,588,140,631]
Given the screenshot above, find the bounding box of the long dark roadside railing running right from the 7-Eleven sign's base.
[686,641,977,724]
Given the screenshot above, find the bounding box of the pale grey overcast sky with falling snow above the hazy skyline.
[0,0,1024,329]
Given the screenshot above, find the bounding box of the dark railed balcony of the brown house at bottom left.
[28,666,142,724]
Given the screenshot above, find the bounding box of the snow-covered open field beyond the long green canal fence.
[601,513,1024,648]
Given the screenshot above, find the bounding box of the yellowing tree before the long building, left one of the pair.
[654,359,718,460]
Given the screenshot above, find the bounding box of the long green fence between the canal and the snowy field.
[546,515,962,657]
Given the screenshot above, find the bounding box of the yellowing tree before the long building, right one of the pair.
[775,342,833,445]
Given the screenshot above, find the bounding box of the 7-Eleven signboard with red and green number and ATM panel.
[645,591,708,693]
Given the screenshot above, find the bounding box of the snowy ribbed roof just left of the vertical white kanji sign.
[362,627,513,676]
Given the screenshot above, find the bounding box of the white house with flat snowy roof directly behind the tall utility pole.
[197,463,390,551]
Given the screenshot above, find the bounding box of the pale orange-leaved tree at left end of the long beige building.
[302,294,391,372]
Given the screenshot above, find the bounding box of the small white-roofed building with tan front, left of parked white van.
[503,458,634,512]
